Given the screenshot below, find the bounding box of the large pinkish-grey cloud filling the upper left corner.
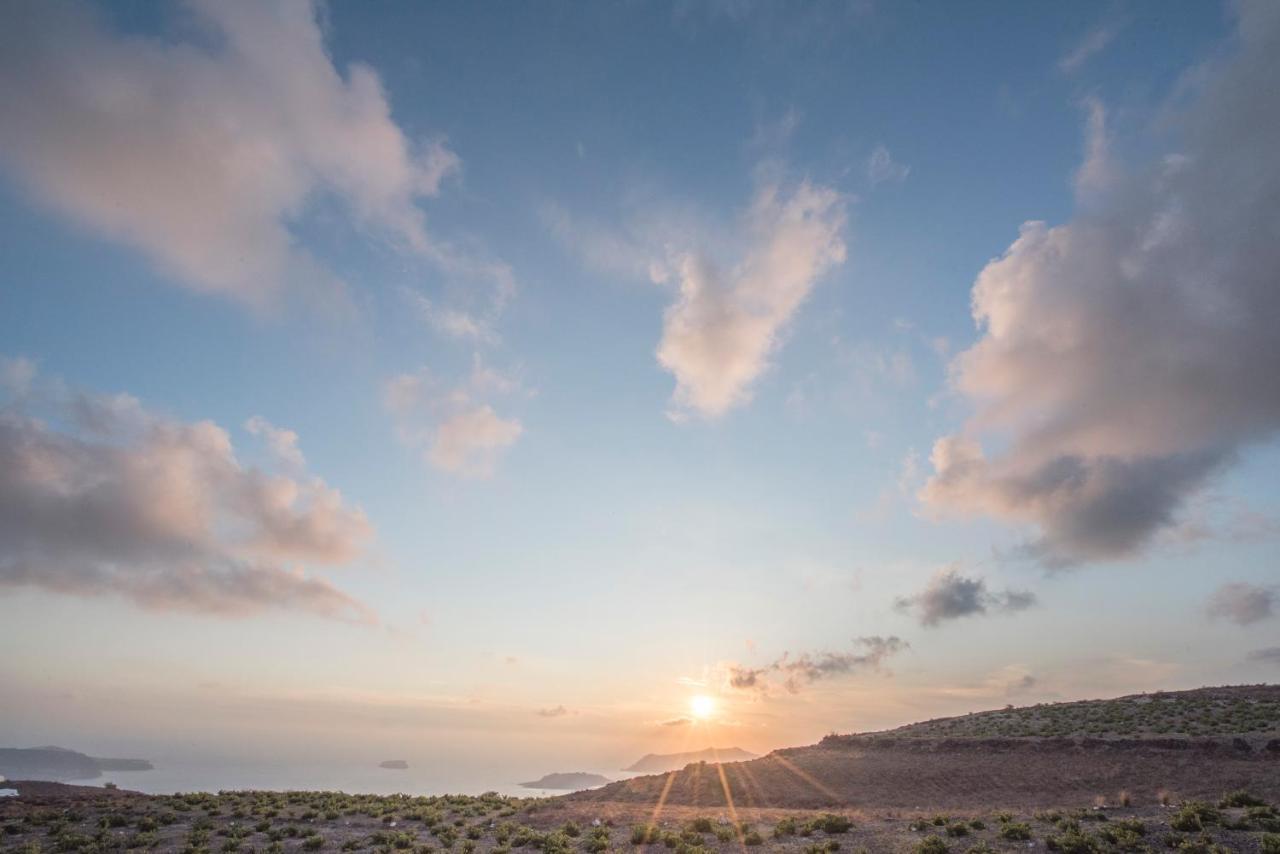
[0,0,509,306]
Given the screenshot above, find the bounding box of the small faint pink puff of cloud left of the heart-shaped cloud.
[383,357,524,478]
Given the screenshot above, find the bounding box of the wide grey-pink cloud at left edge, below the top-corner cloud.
[0,361,374,622]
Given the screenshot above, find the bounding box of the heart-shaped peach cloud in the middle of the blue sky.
[657,182,846,417]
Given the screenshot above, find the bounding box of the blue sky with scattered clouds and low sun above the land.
[0,0,1280,773]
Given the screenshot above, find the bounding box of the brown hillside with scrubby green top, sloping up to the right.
[568,685,1280,809]
